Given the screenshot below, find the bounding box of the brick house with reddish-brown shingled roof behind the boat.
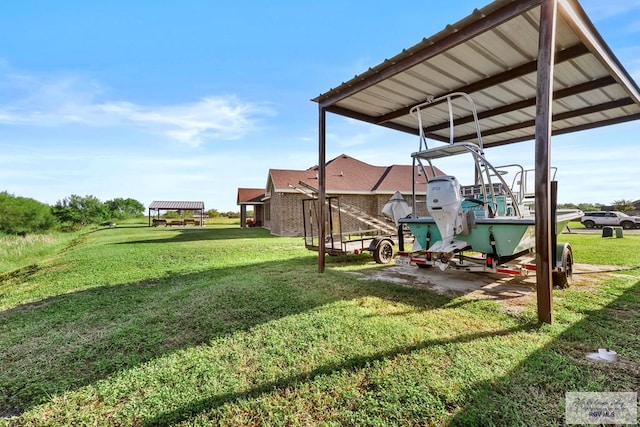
[239,154,442,236]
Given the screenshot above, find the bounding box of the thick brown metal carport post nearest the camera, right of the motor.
[535,0,558,323]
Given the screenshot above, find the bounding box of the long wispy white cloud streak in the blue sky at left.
[0,74,274,147]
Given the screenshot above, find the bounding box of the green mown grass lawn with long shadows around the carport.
[0,223,640,426]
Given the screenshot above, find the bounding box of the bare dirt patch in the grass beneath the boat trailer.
[355,264,624,313]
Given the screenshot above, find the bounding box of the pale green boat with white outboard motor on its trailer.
[396,92,583,287]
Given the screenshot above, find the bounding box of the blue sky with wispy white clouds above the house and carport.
[0,0,640,211]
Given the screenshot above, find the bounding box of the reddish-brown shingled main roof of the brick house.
[269,154,442,194]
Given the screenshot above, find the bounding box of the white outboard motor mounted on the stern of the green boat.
[427,175,468,262]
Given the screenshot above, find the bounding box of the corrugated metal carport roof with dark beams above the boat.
[314,0,640,147]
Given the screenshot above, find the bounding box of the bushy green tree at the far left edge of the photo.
[0,191,58,235]
